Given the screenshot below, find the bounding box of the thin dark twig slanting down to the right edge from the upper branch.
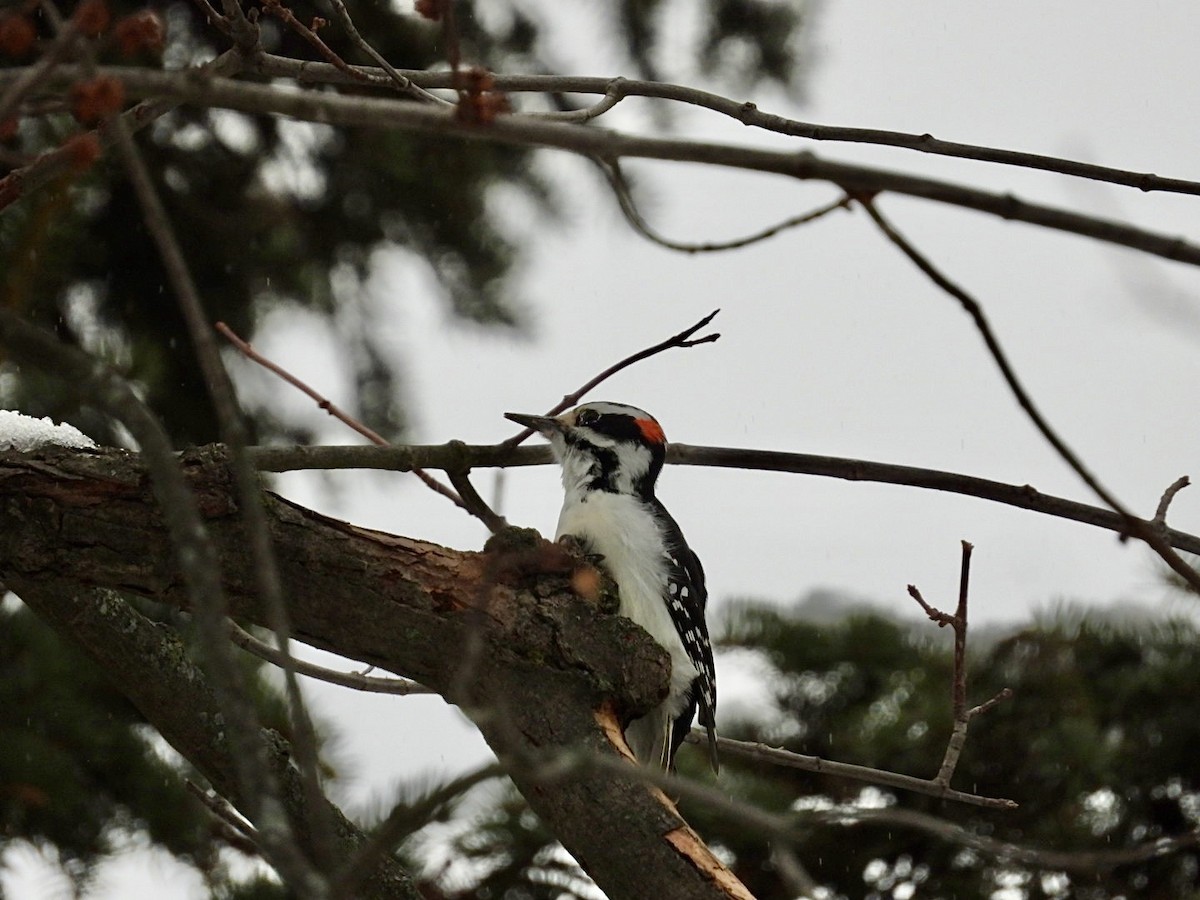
[857,197,1200,593]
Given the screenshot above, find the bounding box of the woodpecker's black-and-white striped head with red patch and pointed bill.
[504,402,667,499]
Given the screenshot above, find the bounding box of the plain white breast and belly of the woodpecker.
[556,490,697,719]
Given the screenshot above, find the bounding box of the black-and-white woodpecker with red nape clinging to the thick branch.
[505,403,719,772]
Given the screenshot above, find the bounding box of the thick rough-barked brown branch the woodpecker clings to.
[0,448,749,900]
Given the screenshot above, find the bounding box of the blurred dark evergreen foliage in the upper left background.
[0,0,803,445]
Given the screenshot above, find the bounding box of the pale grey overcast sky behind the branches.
[4,0,1200,900]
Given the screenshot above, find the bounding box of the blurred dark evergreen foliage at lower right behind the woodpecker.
[424,602,1200,900]
